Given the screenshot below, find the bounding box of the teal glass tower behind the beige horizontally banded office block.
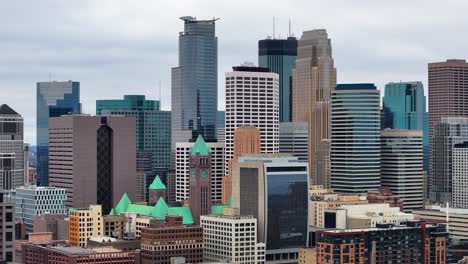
[382,82,429,172]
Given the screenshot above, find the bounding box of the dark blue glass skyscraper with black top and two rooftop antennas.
[258,37,297,122]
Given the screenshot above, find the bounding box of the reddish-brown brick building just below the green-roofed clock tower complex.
[141,217,203,264]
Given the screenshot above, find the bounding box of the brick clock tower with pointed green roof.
[189,135,211,225]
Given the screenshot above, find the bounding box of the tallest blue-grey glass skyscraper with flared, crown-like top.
[171,16,218,146]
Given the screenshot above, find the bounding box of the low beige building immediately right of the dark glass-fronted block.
[309,185,368,228]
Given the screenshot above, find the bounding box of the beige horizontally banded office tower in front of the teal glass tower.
[380,129,426,211]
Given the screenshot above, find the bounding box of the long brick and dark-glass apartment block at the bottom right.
[317,221,451,264]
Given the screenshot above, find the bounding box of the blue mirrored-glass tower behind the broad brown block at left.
[36,81,81,186]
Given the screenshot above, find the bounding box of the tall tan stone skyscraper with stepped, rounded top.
[293,29,336,184]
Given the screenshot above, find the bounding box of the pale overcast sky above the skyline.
[0,0,468,143]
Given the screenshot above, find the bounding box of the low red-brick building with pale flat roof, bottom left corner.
[22,241,141,264]
